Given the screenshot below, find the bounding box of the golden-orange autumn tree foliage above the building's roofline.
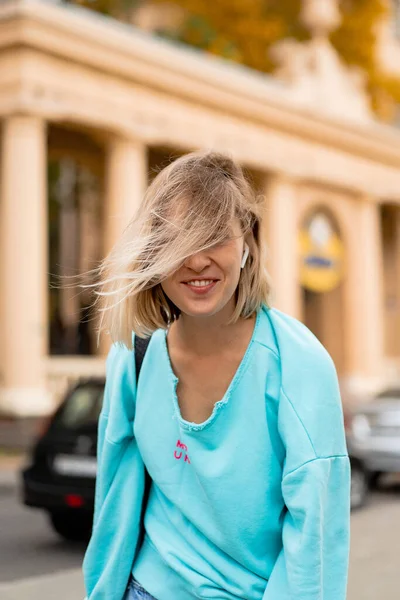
[72,0,400,118]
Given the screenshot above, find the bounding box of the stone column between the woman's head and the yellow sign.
[265,175,301,318]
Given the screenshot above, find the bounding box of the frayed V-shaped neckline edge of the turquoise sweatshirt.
[162,308,262,431]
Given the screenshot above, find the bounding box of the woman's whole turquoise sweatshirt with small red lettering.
[84,308,350,600]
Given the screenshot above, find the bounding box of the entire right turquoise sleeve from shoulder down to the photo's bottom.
[263,311,350,600]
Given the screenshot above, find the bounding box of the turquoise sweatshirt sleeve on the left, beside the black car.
[83,346,144,600]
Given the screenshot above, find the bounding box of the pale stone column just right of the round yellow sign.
[345,197,384,385]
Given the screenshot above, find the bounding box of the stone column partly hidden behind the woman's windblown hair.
[99,138,148,356]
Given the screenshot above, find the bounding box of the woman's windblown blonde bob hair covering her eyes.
[95,152,270,348]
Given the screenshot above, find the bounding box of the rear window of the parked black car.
[55,384,104,429]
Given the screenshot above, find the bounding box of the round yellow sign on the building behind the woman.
[299,212,344,293]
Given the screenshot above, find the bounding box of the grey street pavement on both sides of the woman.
[0,474,400,600]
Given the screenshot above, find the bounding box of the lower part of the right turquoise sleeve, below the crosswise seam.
[263,456,350,600]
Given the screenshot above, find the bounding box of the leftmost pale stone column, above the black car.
[0,116,52,416]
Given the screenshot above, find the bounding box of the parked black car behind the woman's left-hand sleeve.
[22,379,104,540]
